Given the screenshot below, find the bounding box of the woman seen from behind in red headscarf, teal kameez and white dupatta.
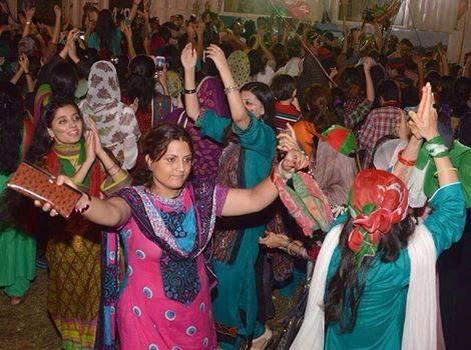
[290,85,466,350]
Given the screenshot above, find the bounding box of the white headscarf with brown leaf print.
[79,61,141,169]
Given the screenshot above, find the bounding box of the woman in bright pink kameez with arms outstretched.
[37,122,307,350]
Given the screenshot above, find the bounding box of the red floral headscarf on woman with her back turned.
[348,169,408,267]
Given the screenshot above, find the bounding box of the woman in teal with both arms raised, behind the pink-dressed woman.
[182,45,276,349]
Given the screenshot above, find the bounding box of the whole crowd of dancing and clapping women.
[0,0,471,350]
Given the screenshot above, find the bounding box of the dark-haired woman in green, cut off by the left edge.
[0,82,36,304]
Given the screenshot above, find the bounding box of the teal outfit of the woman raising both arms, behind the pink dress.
[196,110,276,350]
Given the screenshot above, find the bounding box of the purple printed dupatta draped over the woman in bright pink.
[95,182,221,350]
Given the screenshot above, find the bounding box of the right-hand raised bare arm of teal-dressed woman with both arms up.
[206,45,250,130]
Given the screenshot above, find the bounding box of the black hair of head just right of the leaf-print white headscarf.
[124,55,155,110]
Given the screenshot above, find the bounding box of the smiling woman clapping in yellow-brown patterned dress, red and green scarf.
[26,100,130,349]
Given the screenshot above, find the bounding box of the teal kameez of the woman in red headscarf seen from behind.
[324,183,466,350]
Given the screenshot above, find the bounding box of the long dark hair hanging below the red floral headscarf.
[324,216,415,332]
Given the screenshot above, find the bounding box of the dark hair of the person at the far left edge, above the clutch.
[0,82,24,175]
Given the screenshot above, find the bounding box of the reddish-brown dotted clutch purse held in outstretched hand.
[7,162,82,219]
